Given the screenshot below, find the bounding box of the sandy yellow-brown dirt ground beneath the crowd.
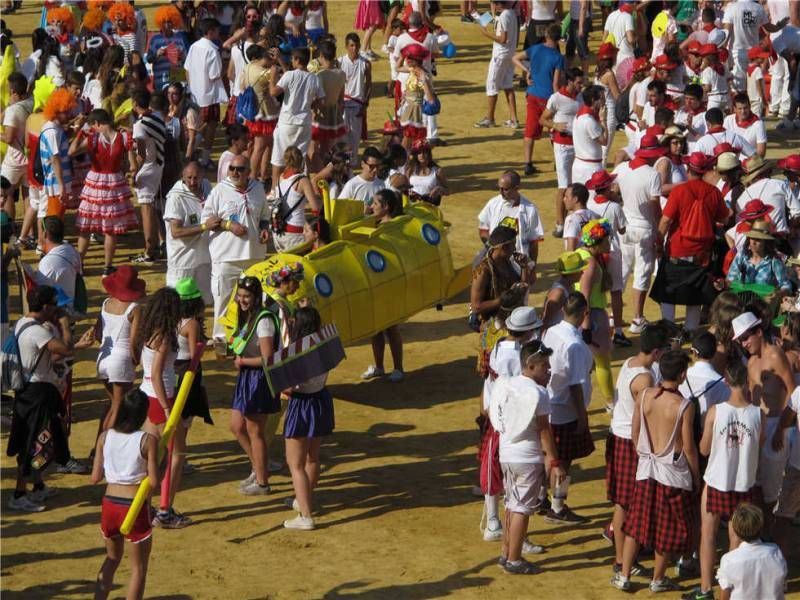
[0,2,800,600]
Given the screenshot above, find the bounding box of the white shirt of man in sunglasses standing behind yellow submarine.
[200,179,269,264]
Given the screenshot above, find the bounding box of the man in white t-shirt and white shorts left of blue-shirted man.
[479,0,519,129]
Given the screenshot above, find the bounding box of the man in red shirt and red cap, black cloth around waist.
[650,152,730,333]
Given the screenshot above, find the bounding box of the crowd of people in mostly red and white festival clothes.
[0,0,800,600]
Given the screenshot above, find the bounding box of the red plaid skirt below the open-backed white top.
[622,479,699,554]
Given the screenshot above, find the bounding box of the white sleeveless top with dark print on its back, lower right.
[703,402,761,492]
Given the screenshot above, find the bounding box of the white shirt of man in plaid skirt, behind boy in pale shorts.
[542,321,594,425]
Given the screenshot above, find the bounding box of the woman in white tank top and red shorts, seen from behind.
[91,390,158,598]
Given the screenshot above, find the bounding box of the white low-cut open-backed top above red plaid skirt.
[636,388,692,491]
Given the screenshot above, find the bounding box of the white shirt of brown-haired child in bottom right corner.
[717,540,786,600]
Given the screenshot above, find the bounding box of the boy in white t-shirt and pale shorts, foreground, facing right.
[490,340,566,575]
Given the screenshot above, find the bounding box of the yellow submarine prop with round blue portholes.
[220,182,472,344]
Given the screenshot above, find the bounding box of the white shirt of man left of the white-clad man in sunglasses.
[164,179,211,269]
